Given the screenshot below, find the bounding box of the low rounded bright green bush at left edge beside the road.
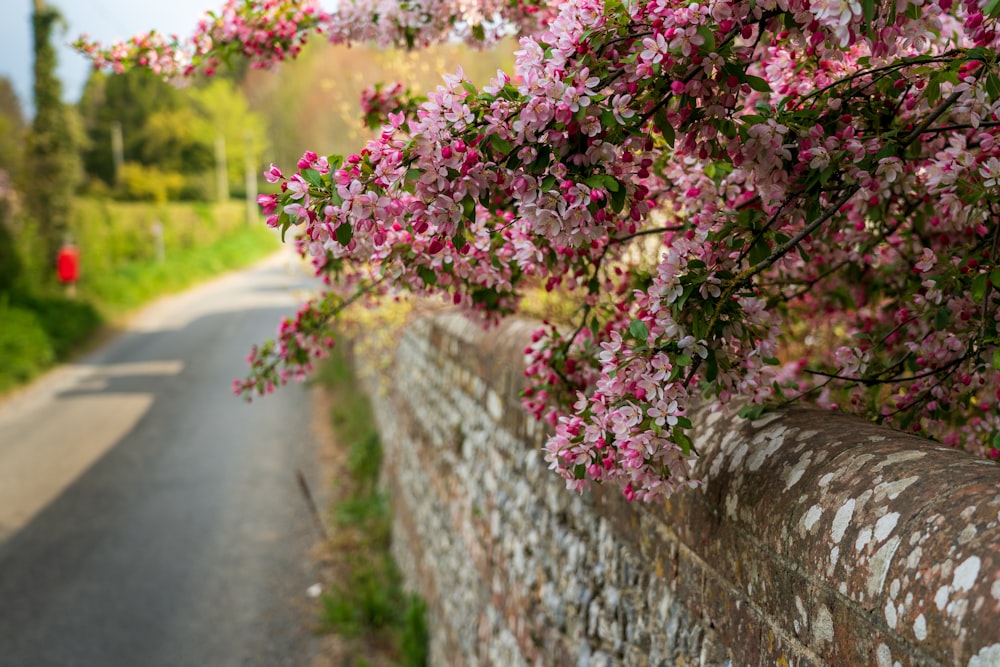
[0,301,56,391]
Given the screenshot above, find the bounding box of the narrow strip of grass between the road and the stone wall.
[314,347,428,667]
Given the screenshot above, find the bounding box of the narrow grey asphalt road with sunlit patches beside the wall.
[0,252,323,667]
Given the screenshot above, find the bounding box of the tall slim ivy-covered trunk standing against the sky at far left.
[21,0,79,272]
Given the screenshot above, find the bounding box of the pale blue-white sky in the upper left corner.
[0,0,224,116]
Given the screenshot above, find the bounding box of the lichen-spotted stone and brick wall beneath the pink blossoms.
[359,313,1000,667]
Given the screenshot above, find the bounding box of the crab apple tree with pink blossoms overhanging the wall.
[81,0,1000,500]
